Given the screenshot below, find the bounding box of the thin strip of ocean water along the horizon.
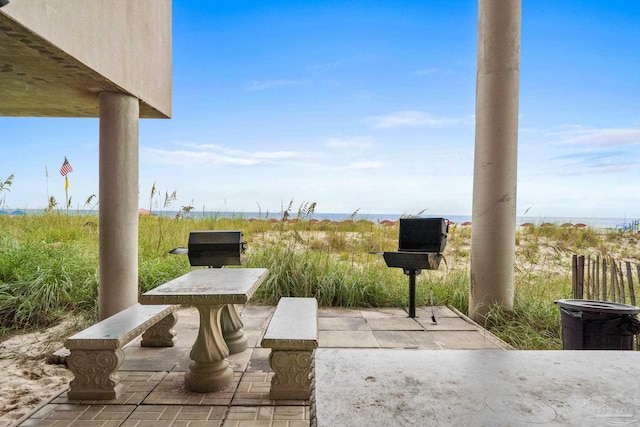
[0,209,638,229]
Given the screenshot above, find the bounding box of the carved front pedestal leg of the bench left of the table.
[67,348,124,400]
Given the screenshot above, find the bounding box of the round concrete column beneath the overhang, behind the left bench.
[98,92,140,319]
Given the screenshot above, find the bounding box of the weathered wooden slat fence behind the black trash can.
[571,255,640,305]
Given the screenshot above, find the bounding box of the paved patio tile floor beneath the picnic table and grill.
[21,305,507,427]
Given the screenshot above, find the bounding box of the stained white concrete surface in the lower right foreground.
[311,348,640,427]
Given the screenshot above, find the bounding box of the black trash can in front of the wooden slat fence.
[555,299,640,350]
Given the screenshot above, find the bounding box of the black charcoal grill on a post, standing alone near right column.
[382,218,449,321]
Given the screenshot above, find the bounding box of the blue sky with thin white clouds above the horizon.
[0,0,640,218]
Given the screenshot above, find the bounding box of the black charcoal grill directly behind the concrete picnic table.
[170,230,247,268]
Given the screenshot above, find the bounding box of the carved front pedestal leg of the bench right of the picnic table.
[269,350,312,400]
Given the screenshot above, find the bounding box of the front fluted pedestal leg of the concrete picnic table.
[185,306,233,393]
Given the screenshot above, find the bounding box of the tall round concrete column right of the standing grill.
[469,0,522,324]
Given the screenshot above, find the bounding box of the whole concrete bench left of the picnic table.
[64,304,180,400]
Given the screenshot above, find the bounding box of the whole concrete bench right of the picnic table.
[261,298,318,400]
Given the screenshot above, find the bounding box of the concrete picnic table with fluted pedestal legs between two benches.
[139,268,269,393]
